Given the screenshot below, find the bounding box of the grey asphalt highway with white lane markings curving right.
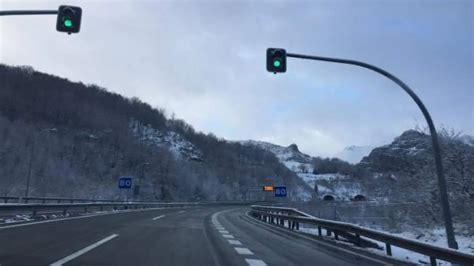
[0,206,404,266]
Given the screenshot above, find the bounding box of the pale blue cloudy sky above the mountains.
[0,0,474,156]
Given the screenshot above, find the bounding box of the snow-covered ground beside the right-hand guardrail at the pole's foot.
[300,227,474,266]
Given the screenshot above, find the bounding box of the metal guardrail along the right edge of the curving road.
[250,205,474,266]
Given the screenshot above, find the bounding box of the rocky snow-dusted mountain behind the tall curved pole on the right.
[356,130,474,227]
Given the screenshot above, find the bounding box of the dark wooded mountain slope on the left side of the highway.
[0,64,311,200]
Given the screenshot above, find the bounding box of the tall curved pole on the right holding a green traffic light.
[286,53,458,249]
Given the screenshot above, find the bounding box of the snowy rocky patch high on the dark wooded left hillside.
[130,121,202,160]
